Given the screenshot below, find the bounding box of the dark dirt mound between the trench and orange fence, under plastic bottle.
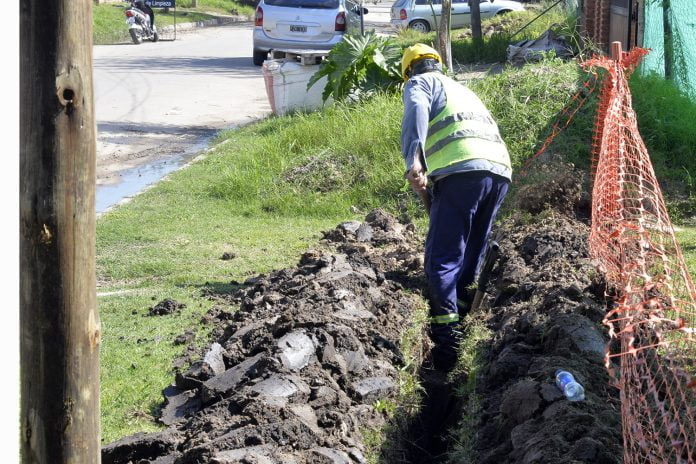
[470,167,623,464]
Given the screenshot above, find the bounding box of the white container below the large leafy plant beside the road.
[262,58,333,115]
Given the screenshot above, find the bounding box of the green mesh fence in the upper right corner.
[641,0,696,99]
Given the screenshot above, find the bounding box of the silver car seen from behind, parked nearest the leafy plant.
[254,0,367,66]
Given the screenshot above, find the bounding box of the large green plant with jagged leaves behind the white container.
[307,31,403,101]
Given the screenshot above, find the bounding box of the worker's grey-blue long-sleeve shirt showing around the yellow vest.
[401,72,512,181]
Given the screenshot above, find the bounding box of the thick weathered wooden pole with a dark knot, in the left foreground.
[19,0,101,464]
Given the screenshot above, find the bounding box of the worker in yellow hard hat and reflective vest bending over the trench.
[401,44,512,371]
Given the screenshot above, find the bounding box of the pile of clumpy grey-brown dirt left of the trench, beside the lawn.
[102,210,430,464]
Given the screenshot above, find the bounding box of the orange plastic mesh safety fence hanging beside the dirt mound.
[583,48,696,463]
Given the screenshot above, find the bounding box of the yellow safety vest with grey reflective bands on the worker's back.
[425,74,511,175]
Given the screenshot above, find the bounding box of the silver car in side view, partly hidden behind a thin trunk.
[391,0,524,32]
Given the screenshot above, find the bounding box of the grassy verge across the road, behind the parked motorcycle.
[92,0,254,45]
